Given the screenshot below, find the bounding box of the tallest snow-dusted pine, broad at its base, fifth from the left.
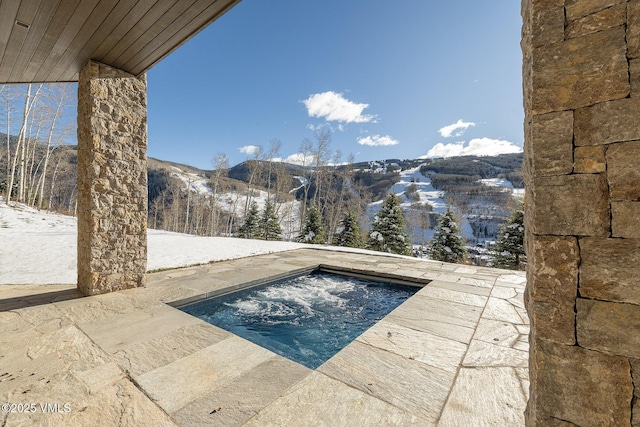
[366,194,411,255]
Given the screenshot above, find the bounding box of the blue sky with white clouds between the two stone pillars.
[148,0,524,169]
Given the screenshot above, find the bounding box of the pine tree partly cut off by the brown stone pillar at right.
[494,203,526,270]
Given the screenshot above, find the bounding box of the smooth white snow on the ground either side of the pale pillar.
[0,198,307,284]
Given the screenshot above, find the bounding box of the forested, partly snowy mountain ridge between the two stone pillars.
[149,153,524,243]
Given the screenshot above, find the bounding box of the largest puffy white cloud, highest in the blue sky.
[302,91,376,123]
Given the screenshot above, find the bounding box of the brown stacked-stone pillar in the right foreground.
[522,0,640,426]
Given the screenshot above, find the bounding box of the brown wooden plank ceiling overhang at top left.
[0,0,240,83]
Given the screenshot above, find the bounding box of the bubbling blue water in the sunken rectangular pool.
[180,272,419,369]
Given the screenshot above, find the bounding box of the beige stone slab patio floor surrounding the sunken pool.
[0,249,529,426]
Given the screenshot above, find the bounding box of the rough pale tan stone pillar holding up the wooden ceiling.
[78,61,147,295]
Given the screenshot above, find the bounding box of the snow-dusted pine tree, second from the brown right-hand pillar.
[429,207,467,263]
